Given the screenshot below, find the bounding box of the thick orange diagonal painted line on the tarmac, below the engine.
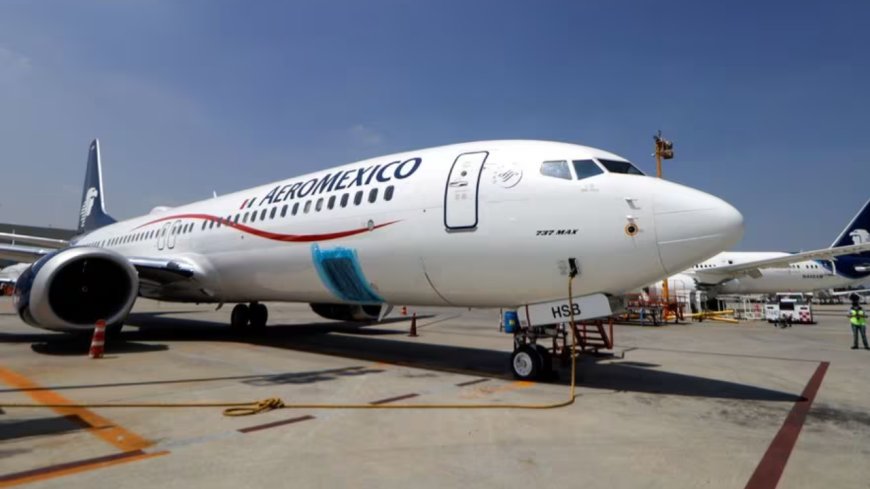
[0,368,153,452]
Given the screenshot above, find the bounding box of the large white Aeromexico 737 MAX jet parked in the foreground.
[0,140,743,373]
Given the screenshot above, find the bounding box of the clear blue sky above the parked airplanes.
[0,0,870,250]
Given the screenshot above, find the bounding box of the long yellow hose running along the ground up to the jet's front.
[0,277,577,416]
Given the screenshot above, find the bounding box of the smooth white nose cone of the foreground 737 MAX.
[653,181,743,275]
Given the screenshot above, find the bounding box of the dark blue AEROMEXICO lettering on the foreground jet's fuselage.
[257,154,423,206]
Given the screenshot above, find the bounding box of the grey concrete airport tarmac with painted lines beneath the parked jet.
[0,298,870,489]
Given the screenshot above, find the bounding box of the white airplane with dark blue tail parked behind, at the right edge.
[650,197,870,297]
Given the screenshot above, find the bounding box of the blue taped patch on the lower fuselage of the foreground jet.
[311,244,384,304]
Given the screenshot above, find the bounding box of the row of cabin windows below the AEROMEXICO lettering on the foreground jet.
[95,185,395,248]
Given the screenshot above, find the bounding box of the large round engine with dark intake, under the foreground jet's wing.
[14,247,139,331]
